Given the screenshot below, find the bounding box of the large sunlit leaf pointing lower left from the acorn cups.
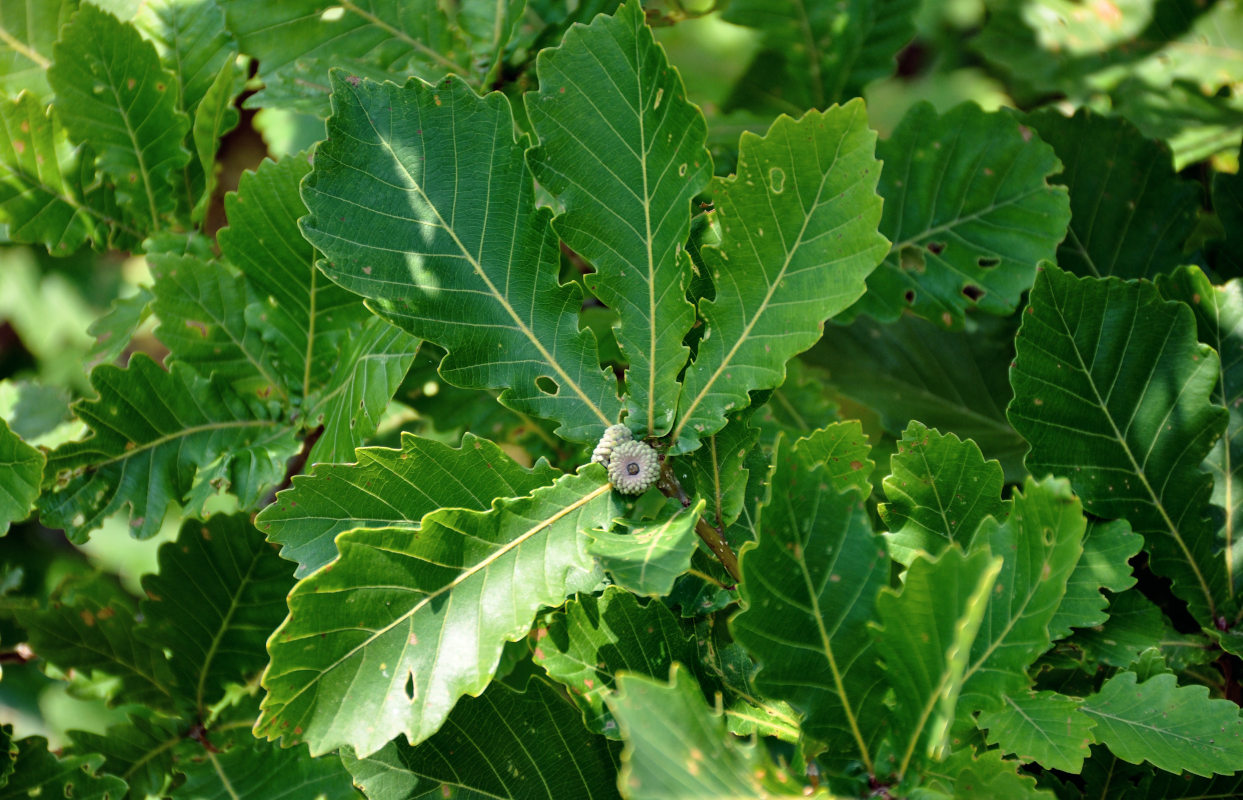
[255,465,619,757]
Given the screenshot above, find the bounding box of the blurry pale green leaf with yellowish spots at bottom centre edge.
[608,667,827,800]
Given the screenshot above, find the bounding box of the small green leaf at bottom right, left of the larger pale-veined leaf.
[977,692,1096,774]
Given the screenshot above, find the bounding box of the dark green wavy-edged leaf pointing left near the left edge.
[39,354,297,543]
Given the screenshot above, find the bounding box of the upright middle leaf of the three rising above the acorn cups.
[526,0,712,436]
